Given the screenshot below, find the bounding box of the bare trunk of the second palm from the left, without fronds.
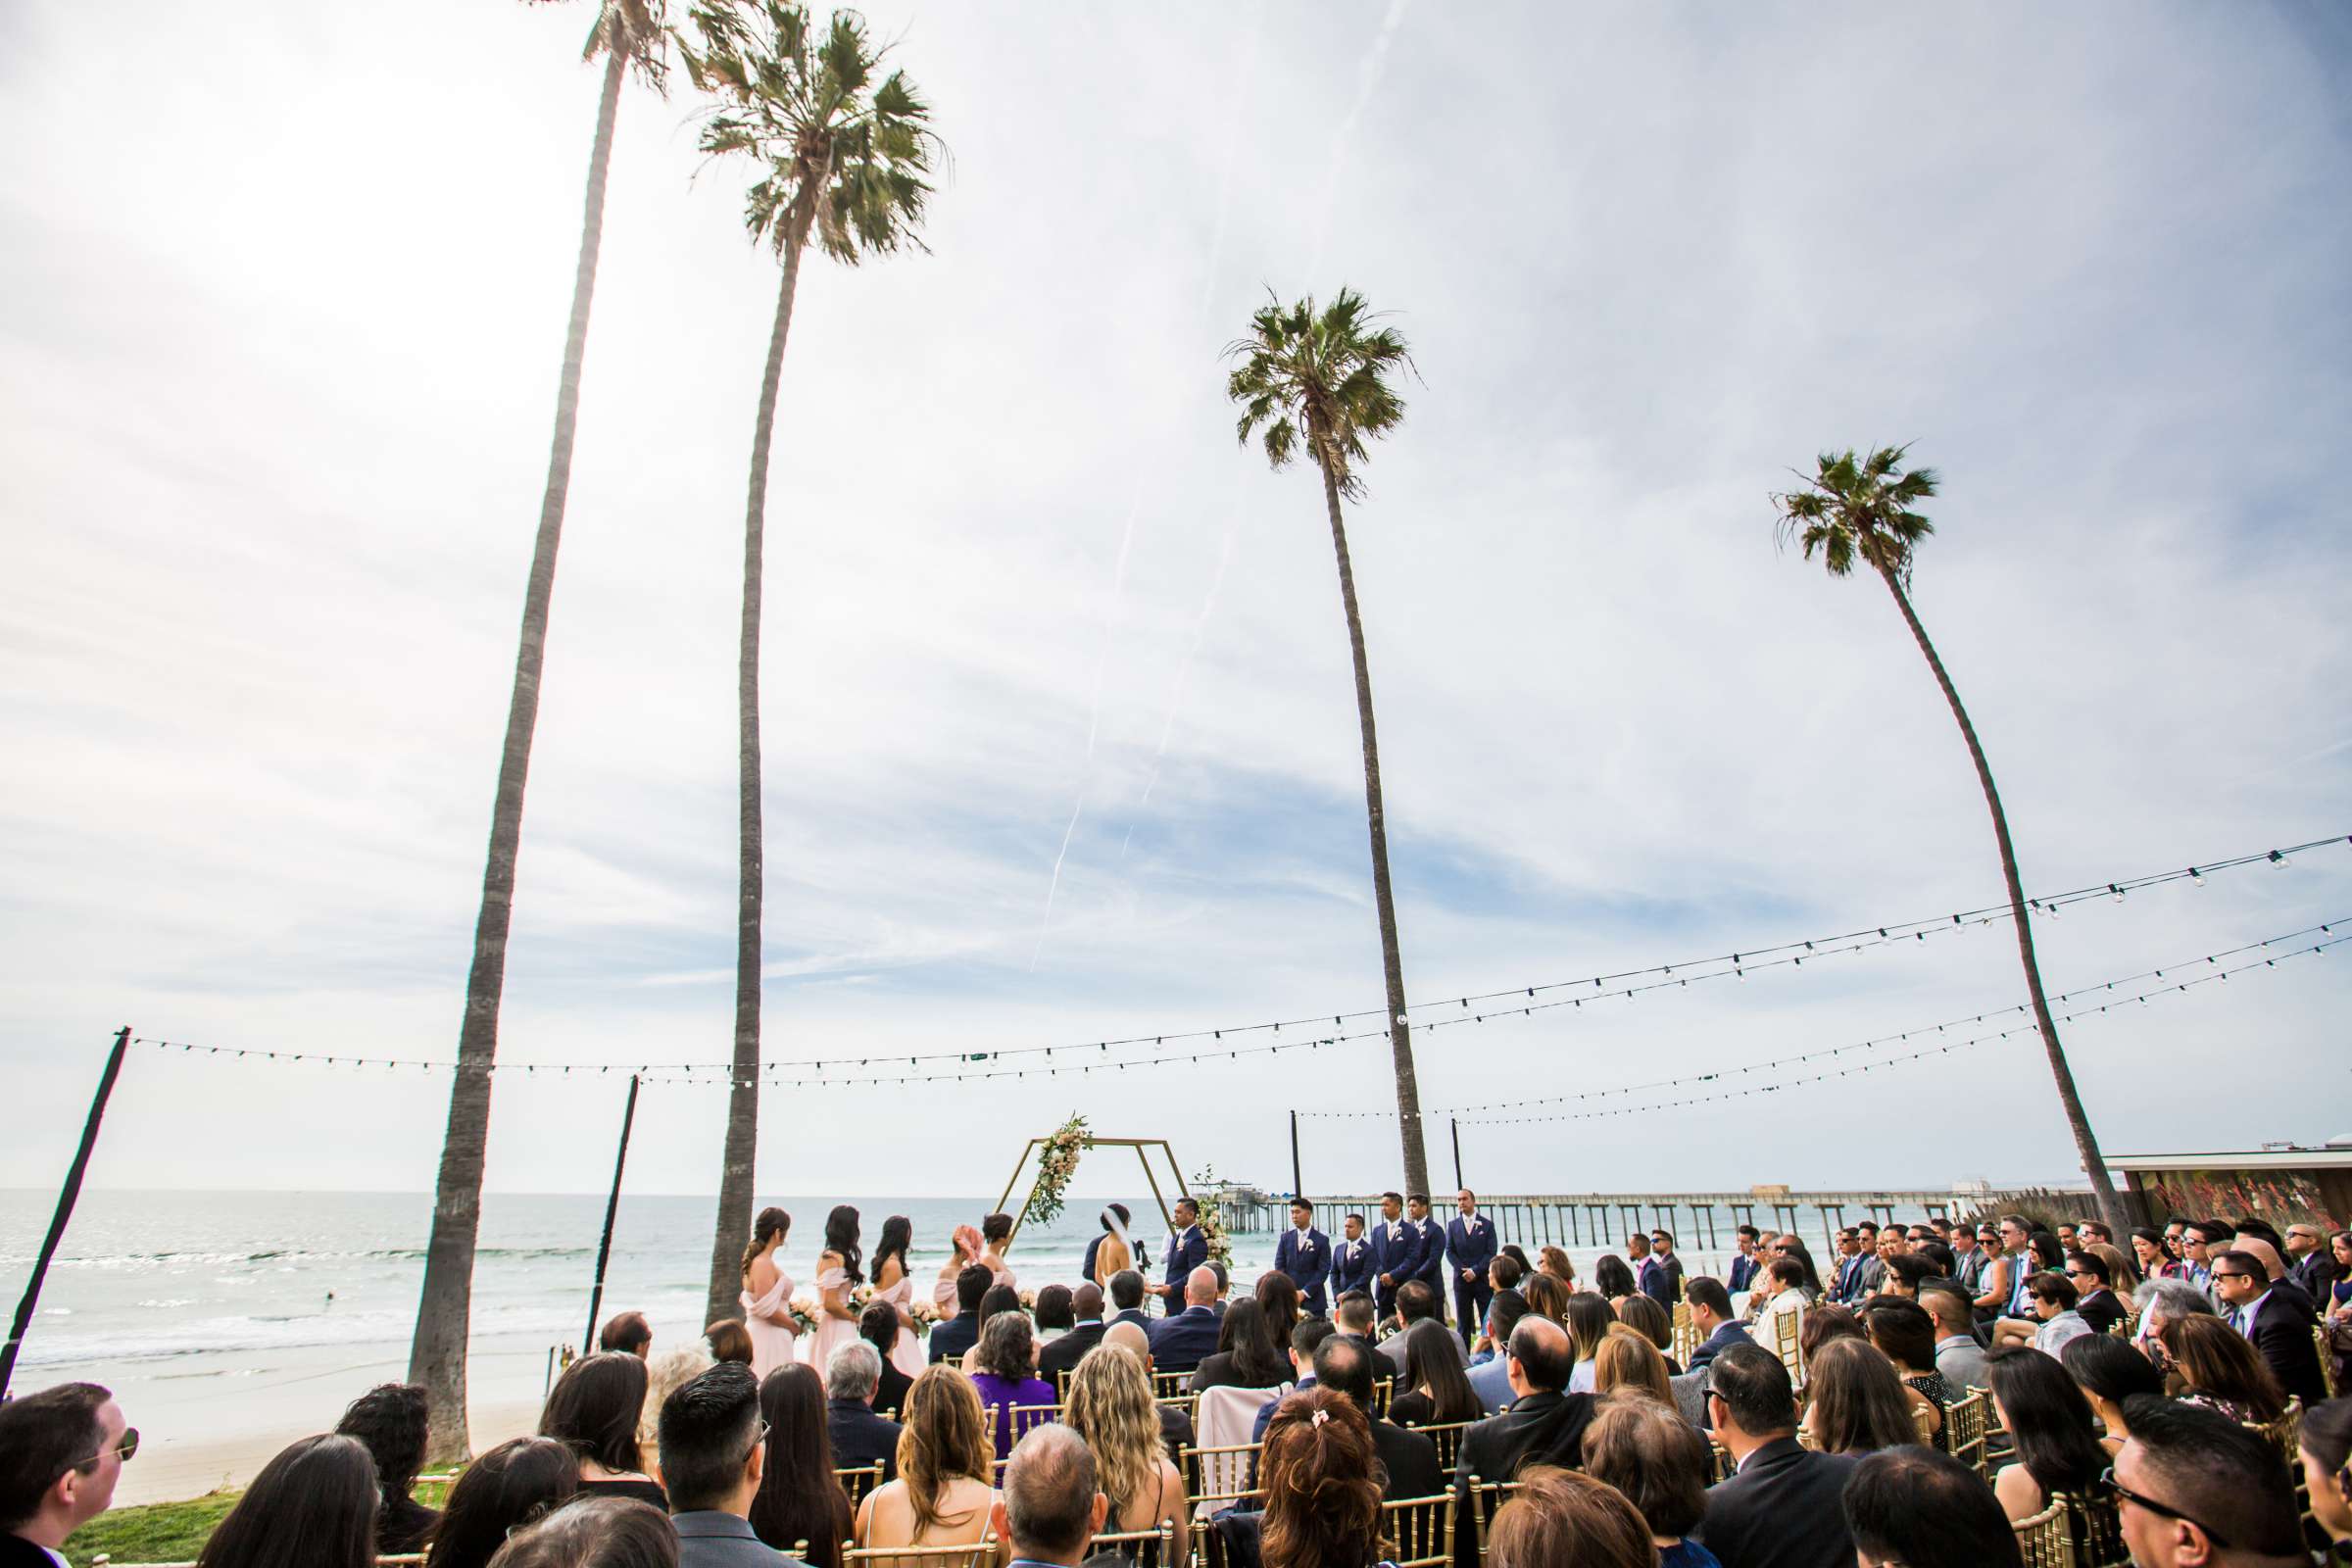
[704,242,800,1324]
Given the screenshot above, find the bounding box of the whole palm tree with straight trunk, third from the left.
[1225,289,1430,1192]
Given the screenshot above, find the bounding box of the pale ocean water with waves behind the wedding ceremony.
[0,1190,1768,1502]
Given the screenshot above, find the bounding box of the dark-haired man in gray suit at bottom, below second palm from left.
[659,1361,805,1568]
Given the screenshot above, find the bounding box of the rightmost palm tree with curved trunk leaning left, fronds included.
[1774,447,2131,1234]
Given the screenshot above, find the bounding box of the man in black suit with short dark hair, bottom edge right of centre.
[1695,1345,1858,1568]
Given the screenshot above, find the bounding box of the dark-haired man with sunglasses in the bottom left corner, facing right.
[0,1382,139,1568]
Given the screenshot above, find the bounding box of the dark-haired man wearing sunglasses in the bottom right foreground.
[2112,1396,2312,1568]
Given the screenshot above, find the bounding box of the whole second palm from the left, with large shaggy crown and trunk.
[684,0,941,1321]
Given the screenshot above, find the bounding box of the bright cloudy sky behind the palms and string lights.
[0,0,2352,1203]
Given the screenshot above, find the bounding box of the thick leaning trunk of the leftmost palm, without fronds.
[410,49,623,1462]
